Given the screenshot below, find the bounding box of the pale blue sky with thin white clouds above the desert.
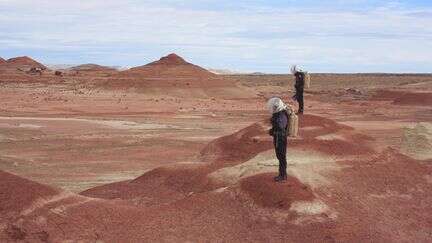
[0,0,432,73]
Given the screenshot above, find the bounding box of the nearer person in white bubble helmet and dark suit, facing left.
[267,97,290,182]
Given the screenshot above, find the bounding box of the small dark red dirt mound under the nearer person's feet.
[240,173,315,209]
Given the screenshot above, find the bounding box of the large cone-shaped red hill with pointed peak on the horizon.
[100,54,240,95]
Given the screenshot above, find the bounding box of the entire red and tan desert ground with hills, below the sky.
[0,53,432,242]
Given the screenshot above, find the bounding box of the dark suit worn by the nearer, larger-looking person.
[270,110,288,176]
